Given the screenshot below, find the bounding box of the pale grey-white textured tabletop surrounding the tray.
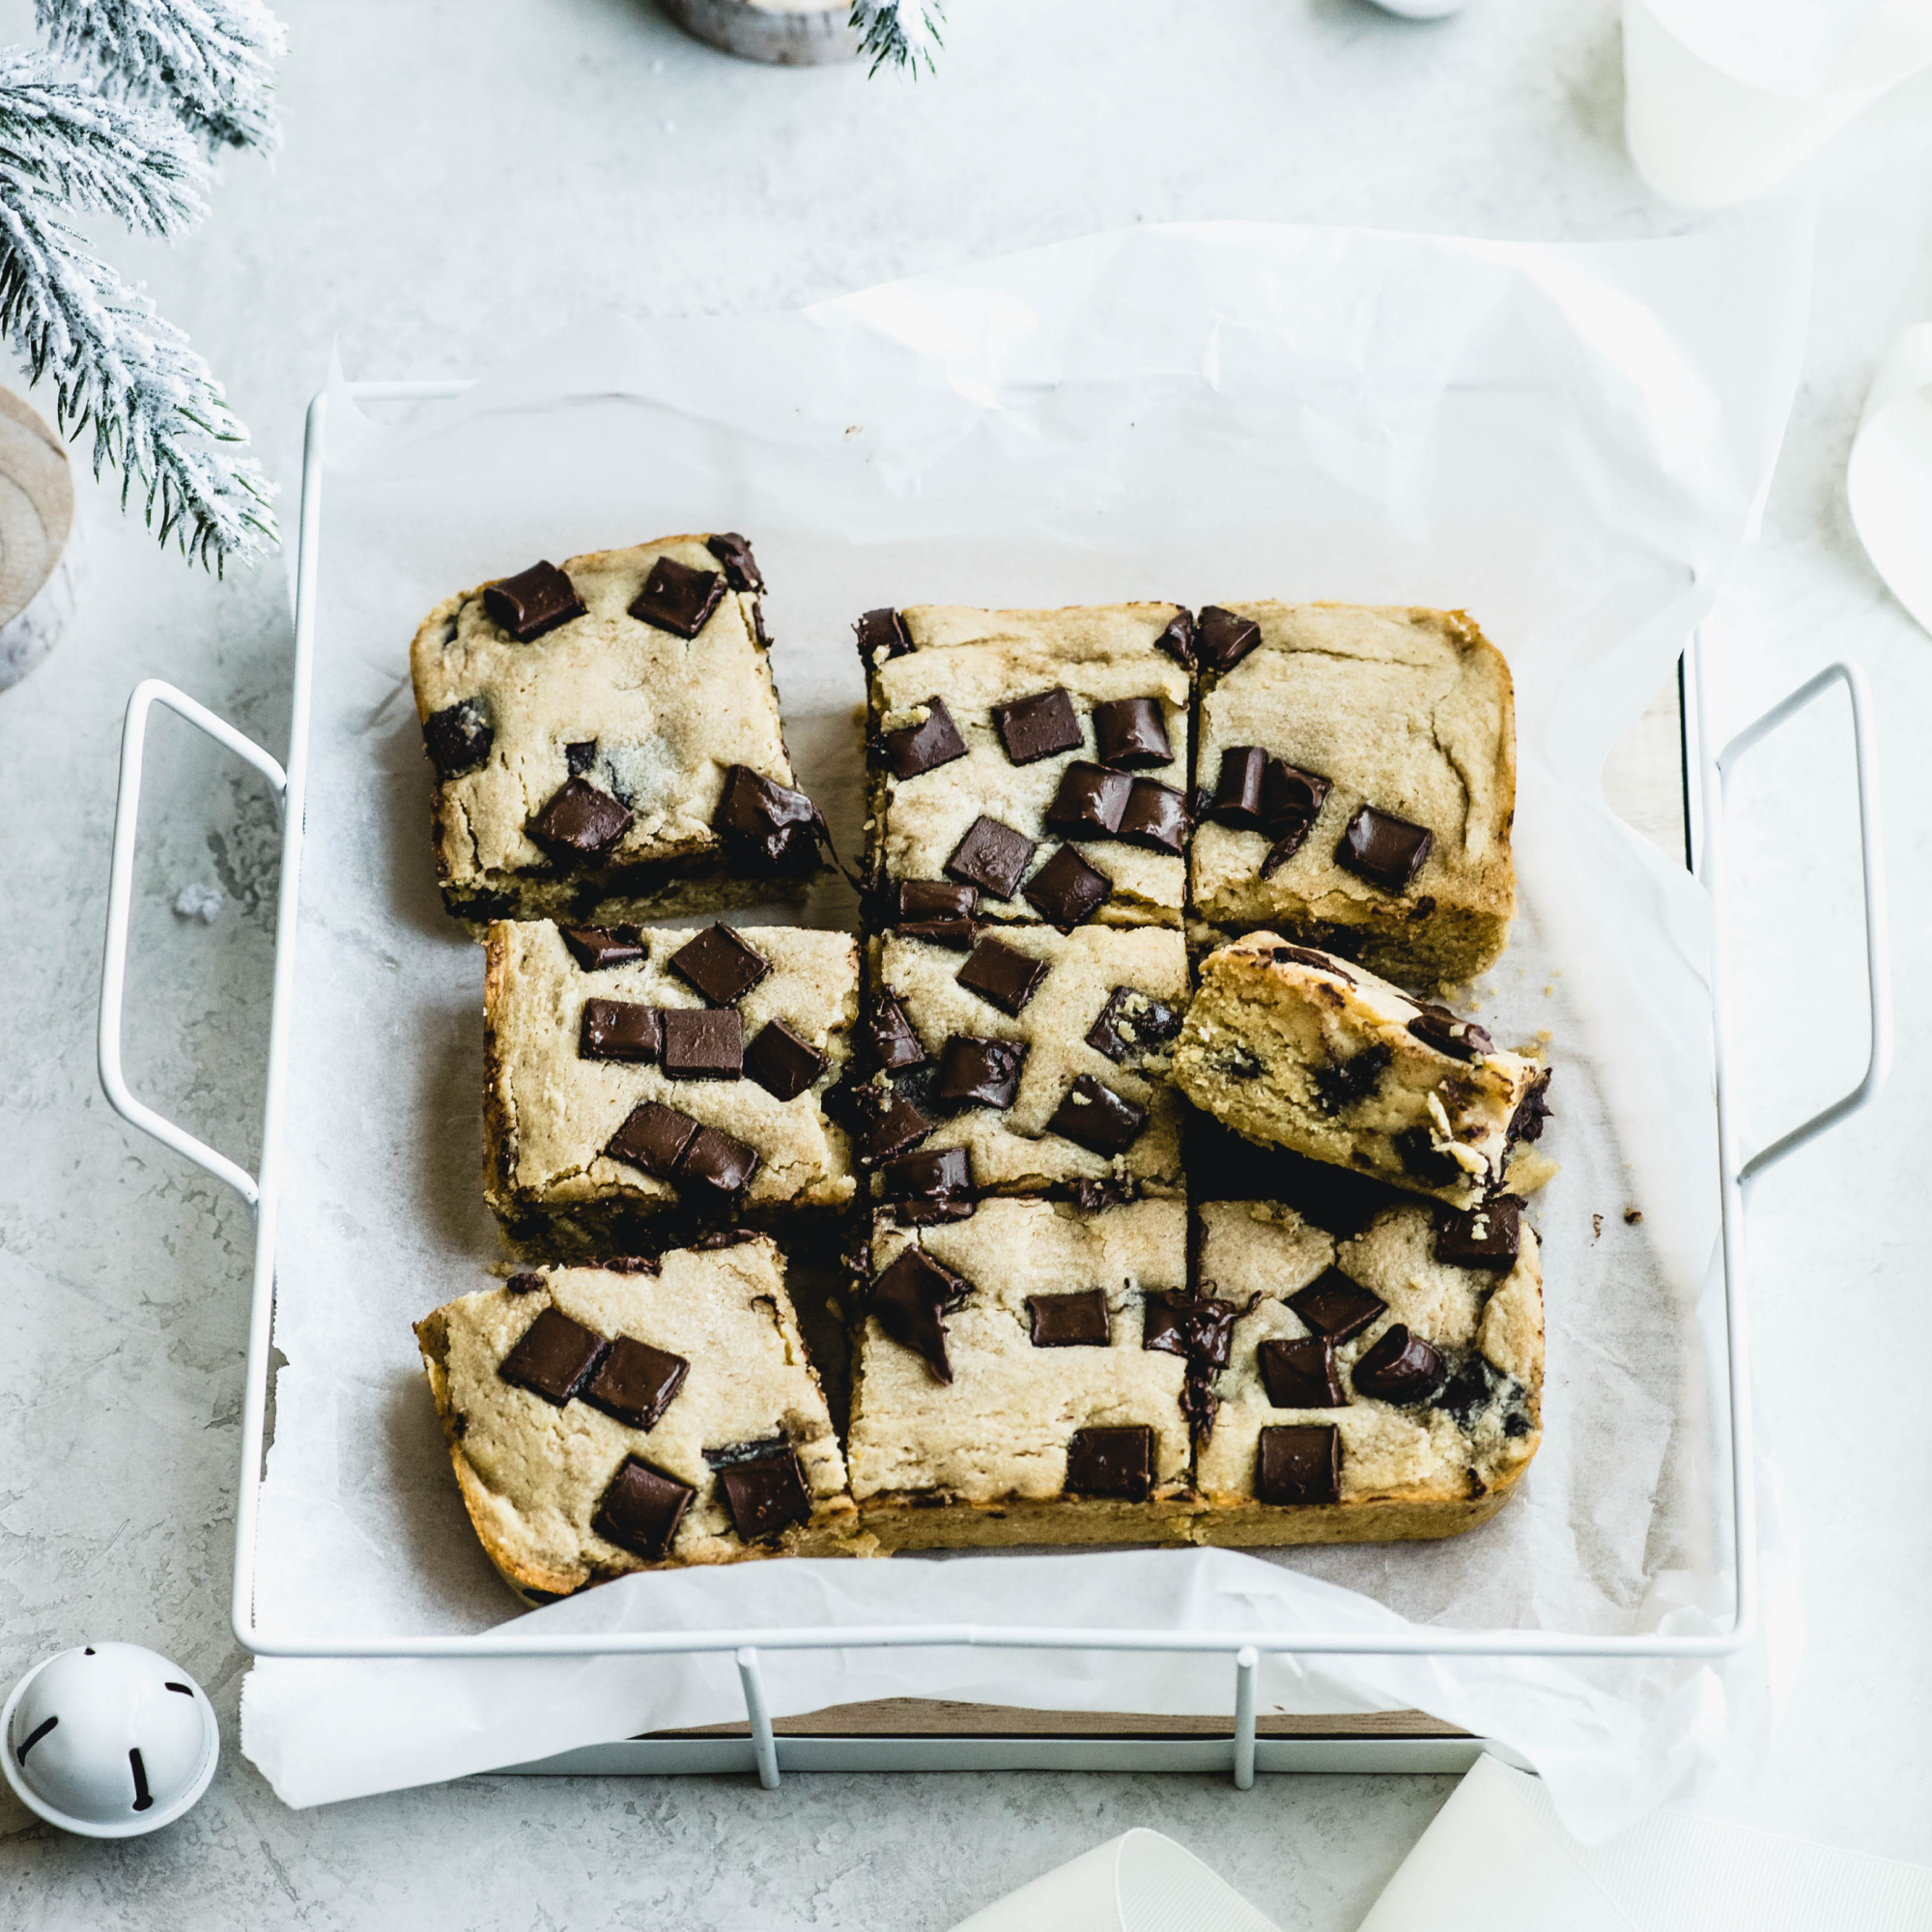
[0,0,1932,1932]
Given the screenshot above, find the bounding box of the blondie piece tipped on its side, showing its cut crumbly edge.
[1173,933,1549,1208]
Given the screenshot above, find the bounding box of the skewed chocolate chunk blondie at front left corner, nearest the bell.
[415,1233,873,1598]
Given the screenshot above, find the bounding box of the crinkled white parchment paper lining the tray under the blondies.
[243,224,1808,1833]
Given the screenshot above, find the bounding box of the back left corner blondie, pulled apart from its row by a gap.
[410,533,823,931]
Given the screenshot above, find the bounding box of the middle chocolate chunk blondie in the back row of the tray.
[858,603,1190,929]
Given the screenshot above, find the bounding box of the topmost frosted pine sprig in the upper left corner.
[33,0,288,153]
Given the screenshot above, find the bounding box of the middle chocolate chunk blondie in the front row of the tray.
[848,1200,1192,1549]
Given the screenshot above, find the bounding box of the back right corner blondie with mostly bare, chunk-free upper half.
[1190,603,1517,987]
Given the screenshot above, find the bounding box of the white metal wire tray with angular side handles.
[100,383,1891,1787]
